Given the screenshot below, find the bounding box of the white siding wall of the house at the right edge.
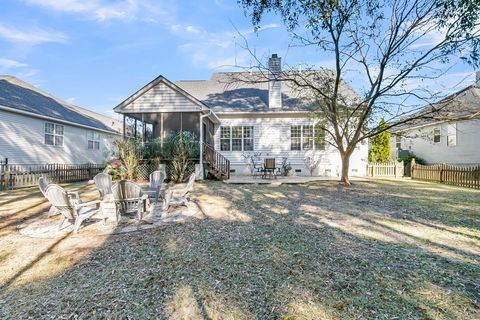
[391,119,480,164]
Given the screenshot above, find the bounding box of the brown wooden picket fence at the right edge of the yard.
[411,159,480,189]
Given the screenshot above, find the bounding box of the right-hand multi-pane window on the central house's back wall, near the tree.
[290,125,325,151]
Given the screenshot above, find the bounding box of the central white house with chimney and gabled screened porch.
[114,55,368,177]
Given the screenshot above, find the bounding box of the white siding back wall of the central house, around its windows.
[215,115,368,177]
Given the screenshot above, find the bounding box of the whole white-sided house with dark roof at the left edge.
[0,76,122,164]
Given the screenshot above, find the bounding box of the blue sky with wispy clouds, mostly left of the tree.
[0,0,472,115]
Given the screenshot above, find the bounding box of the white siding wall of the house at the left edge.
[0,110,121,164]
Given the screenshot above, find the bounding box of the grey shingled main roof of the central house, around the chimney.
[175,70,356,113]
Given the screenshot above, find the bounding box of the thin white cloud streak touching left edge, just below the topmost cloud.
[0,24,68,44]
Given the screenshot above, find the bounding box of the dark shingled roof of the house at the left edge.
[0,76,121,133]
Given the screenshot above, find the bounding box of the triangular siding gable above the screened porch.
[122,82,200,112]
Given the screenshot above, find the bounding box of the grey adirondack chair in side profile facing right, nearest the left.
[45,184,105,233]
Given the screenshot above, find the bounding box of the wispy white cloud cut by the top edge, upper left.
[25,0,169,22]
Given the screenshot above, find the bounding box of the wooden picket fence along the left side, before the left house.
[0,159,105,190]
